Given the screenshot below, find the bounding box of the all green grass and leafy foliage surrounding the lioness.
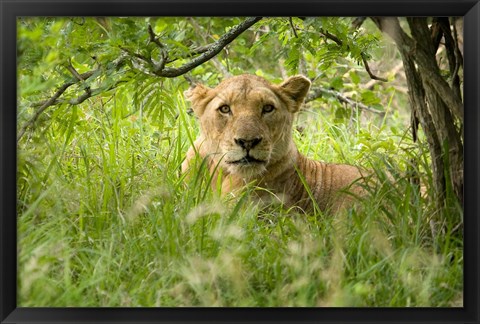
[17,17,463,306]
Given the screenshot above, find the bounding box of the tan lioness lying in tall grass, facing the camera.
[182,75,362,211]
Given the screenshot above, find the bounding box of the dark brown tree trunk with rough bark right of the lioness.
[372,17,463,213]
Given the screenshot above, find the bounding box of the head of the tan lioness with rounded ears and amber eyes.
[186,75,310,179]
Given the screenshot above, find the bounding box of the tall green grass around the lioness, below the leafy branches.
[17,86,463,307]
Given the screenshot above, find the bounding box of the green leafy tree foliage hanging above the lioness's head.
[18,17,396,134]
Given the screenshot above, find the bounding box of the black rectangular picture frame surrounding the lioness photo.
[0,0,480,323]
